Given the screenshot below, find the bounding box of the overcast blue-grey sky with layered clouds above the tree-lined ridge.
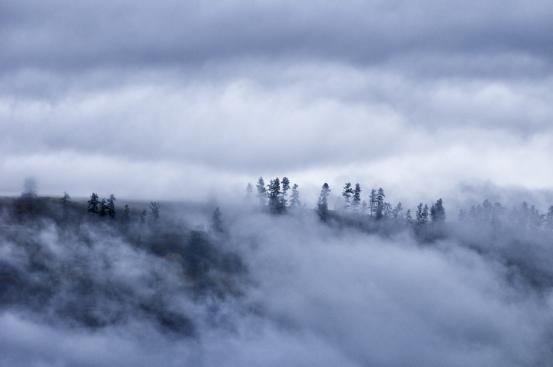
[0,0,553,206]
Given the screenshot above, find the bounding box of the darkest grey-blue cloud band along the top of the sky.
[0,0,553,74]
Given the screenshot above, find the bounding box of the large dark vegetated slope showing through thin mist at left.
[0,185,247,336]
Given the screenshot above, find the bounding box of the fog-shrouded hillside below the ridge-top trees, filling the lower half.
[0,191,553,366]
